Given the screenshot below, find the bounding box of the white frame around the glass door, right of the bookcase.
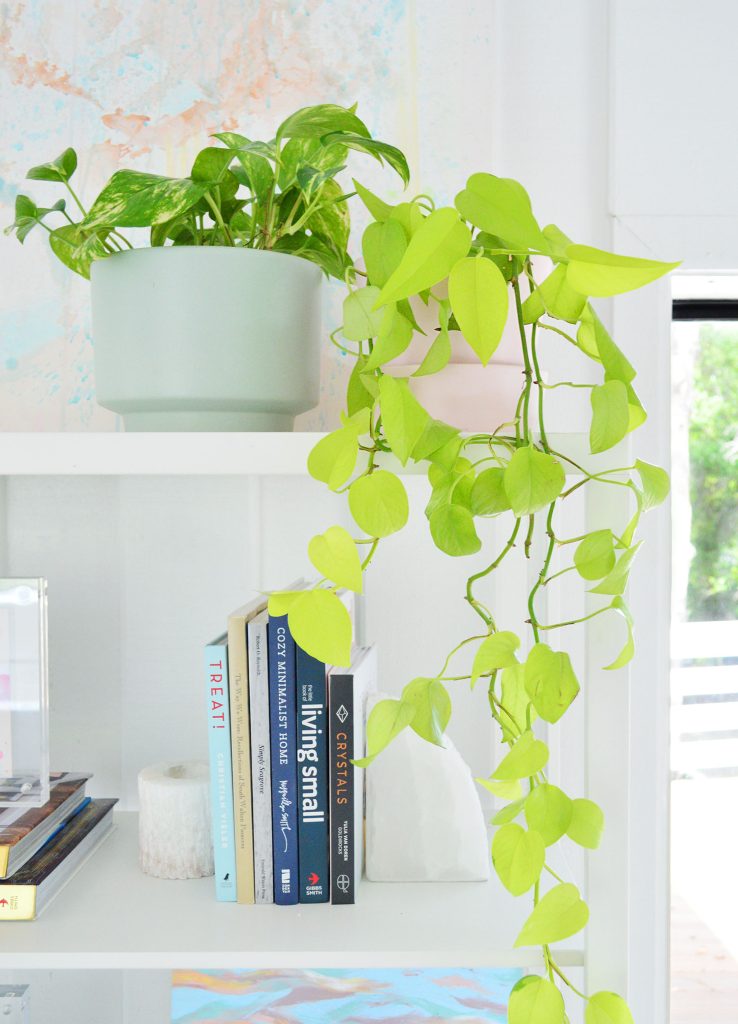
[613,216,738,1024]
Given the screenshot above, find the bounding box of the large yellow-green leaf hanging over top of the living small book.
[288,590,352,666]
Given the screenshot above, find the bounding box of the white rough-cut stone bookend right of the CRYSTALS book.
[366,708,489,882]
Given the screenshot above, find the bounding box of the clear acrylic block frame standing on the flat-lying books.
[0,579,49,809]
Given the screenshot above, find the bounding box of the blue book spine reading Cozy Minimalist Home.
[267,615,299,904]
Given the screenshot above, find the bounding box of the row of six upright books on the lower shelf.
[205,586,376,904]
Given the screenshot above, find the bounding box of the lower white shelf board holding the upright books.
[0,814,583,970]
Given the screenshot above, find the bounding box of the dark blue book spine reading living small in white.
[297,647,331,903]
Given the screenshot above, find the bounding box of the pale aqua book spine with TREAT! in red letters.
[205,638,236,903]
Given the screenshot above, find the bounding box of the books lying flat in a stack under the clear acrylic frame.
[0,772,118,921]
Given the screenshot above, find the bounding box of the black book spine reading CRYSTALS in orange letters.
[329,675,354,903]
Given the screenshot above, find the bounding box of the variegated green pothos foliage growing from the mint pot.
[5,103,408,280]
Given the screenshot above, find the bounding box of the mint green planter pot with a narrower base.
[91,246,321,431]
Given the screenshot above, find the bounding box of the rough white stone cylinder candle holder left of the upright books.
[138,761,214,879]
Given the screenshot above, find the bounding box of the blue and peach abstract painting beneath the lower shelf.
[172,968,521,1024]
